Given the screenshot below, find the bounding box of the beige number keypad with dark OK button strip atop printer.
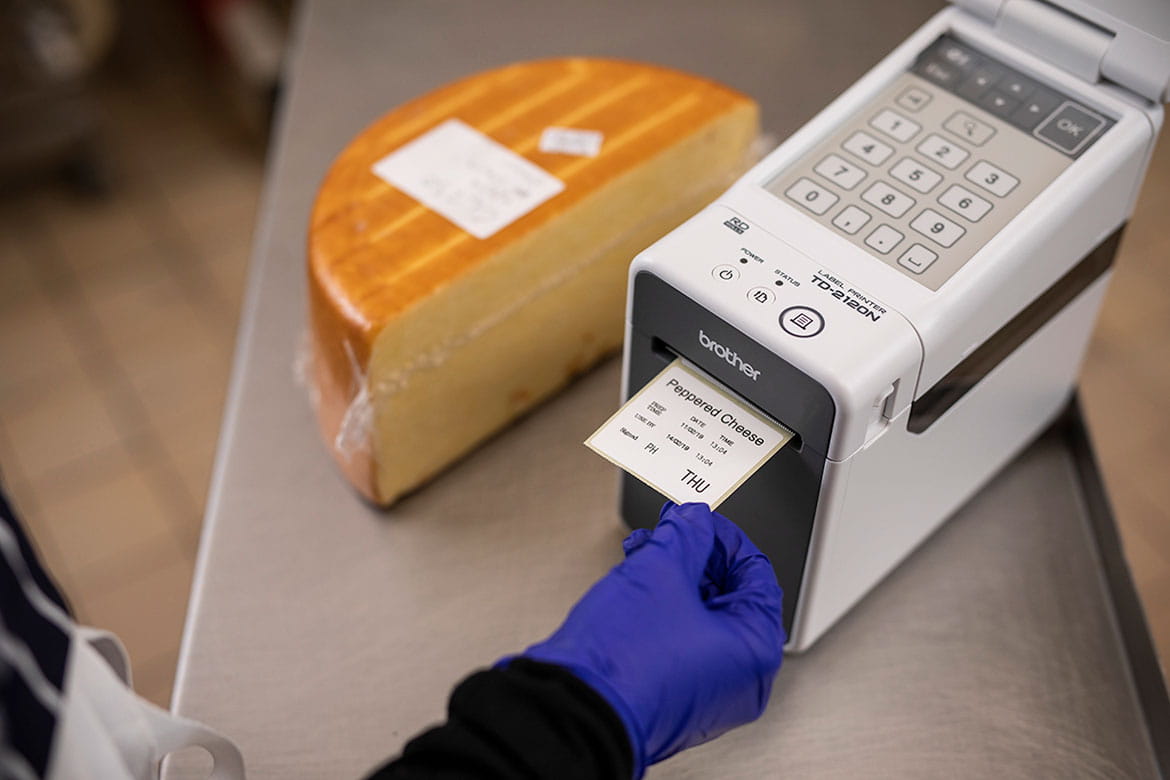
[765,36,1113,290]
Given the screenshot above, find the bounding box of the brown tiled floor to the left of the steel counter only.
[0,67,263,705]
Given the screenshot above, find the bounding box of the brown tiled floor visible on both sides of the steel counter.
[0,62,1170,704]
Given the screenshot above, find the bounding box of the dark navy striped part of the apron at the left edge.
[0,490,73,779]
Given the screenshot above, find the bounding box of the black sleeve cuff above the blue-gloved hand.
[369,658,633,780]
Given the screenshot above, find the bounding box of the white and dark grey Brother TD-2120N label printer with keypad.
[620,0,1170,651]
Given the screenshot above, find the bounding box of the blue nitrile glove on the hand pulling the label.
[523,504,786,778]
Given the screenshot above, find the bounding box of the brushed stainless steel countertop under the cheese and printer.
[171,0,1158,779]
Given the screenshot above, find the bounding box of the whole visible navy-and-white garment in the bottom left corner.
[0,481,245,780]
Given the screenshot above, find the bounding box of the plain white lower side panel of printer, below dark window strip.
[789,272,1109,651]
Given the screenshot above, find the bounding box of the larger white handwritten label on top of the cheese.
[373,119,565,239]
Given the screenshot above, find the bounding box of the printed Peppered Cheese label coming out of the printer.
[585,359,792,509]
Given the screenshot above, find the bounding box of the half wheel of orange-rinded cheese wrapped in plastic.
[308,58,758,504]
